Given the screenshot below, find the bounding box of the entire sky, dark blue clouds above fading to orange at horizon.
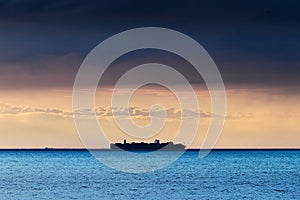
[0,0,300,148]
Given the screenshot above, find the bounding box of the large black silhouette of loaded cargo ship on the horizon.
[110,140,186,151]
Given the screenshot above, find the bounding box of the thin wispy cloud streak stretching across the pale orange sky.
[0,103,258,120]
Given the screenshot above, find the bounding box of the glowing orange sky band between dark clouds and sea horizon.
[0,87,300,148]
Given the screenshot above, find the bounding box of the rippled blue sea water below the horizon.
[0,151,300,199]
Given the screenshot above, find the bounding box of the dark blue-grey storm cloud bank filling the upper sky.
[0,0,300,87]
